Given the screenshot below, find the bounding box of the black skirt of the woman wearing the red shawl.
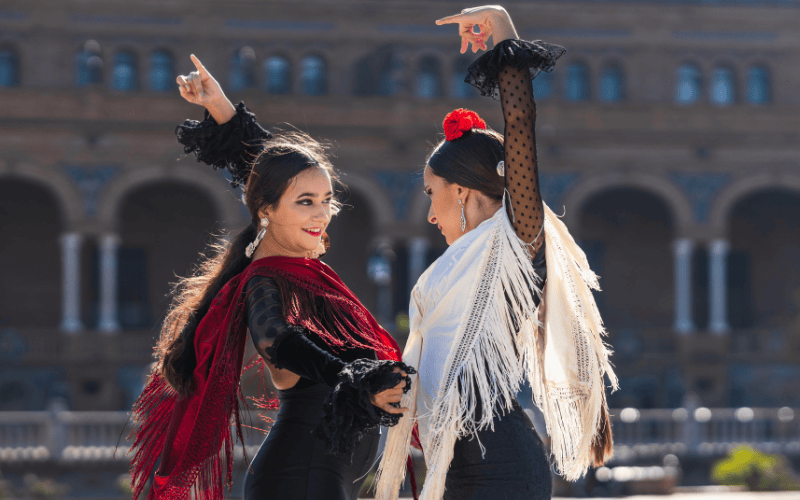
[244,379,380,500]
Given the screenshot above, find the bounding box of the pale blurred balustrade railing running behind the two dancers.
[0,407,800,463]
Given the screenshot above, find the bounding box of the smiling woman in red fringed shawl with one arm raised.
[131,56,414,500]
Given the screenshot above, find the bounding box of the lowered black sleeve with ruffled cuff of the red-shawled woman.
[246,276,416,455]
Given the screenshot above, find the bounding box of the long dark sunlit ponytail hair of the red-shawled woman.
[156,132,339,395]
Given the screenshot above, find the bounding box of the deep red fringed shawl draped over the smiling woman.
[131,257,402,500]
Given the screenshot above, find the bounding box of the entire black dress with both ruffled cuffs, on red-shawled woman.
[176,115,413,500]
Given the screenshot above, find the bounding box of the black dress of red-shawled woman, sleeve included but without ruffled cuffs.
[244,277,380,500]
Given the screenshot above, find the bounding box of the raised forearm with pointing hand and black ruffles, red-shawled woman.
[175,55,272,187]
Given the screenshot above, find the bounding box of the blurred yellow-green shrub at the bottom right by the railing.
[711,446,800,491]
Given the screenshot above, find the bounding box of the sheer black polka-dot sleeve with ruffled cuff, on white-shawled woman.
[467,39,565,260]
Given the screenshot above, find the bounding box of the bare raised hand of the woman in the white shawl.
[436,5,518,54]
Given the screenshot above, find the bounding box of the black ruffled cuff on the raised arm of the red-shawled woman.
[175,102,272,187]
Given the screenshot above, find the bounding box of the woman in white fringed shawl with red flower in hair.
[376,6,617,500]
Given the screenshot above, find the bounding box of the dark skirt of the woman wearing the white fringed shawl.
[444,401,553,500]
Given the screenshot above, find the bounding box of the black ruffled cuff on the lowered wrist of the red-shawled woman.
[315,359,417,457]
